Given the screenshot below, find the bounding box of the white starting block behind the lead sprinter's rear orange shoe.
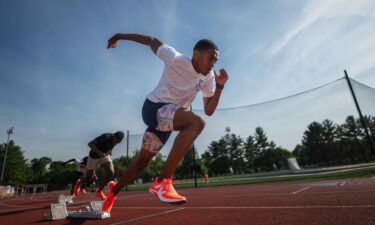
[42,201,111,220]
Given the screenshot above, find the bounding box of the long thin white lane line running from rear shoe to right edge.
[113,205,375,210]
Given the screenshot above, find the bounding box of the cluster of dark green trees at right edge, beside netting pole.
[293,116,375,166]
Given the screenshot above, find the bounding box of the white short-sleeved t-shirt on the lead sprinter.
[147,44,216,108]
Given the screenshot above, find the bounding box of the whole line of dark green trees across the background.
[0,116,375,190]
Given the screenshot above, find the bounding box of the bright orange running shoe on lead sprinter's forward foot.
[150,179,186,203]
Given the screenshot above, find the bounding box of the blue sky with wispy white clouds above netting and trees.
[0,0,375,160]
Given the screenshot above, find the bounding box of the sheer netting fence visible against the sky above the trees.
[122,78,375,157]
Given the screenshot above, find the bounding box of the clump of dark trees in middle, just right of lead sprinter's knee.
[202,127,292,175]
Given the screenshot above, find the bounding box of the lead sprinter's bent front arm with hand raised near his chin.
[203,69,228,116]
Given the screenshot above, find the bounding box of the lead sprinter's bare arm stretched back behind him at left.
[107,33,163,54]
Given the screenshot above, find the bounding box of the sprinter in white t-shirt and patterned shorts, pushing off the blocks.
[103,34,228,212]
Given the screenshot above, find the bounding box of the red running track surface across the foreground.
[0,179,375,225]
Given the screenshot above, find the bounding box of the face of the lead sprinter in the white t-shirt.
[193,48,219,75]
